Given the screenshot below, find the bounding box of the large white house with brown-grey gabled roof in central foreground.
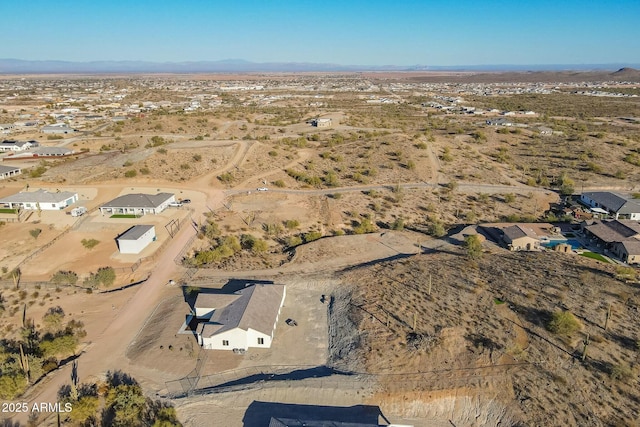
[195,284,286,350]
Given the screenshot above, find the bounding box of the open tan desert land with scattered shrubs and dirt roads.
[0,70,640,426]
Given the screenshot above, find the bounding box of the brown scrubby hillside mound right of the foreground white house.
[332,251,640,425]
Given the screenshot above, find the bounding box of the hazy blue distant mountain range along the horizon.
[0,59,640,77]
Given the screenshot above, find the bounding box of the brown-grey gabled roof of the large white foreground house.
[196,284,285,338]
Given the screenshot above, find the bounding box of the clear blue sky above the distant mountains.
[5,0,640,65]
